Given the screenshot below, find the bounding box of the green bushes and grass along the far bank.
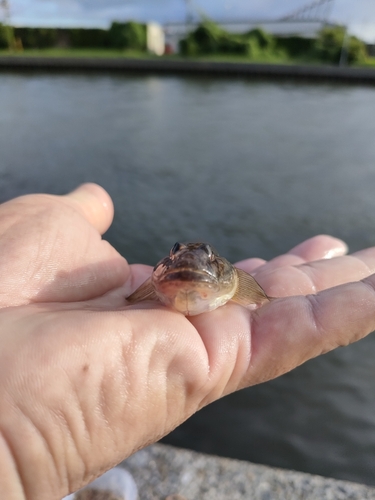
[0,20,374,66]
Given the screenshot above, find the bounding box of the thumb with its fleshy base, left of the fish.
[0,184,128,307]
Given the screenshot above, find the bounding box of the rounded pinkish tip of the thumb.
[63,183,114,234]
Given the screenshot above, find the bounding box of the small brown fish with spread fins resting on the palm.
[127,243,270,316]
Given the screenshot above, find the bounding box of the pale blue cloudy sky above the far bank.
[0,0,375,43]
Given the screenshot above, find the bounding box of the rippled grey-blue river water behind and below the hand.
[0,73,375,485]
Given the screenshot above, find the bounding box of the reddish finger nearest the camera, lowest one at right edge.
[246,275,375,385]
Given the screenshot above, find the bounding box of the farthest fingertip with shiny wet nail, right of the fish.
[253,234,348,271]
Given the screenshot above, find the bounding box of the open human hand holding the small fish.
[0,184,375,500]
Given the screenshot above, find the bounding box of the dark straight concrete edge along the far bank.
[0,56,375,84]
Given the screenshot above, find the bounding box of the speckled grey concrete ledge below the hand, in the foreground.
[122,444,375,500]
